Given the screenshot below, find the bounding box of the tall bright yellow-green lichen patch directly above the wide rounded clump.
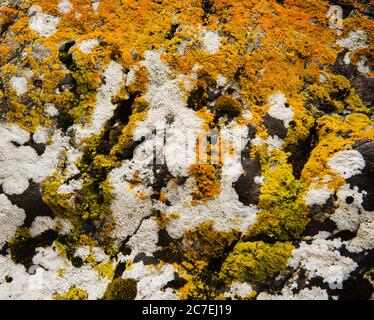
[248,150,309,241]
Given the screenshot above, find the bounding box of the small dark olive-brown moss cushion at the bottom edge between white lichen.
[103,278,137,300]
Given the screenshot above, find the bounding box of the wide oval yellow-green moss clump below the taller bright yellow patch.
[221,241,294,283]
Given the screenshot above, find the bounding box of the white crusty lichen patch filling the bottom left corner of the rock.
[0,246,109,300]
